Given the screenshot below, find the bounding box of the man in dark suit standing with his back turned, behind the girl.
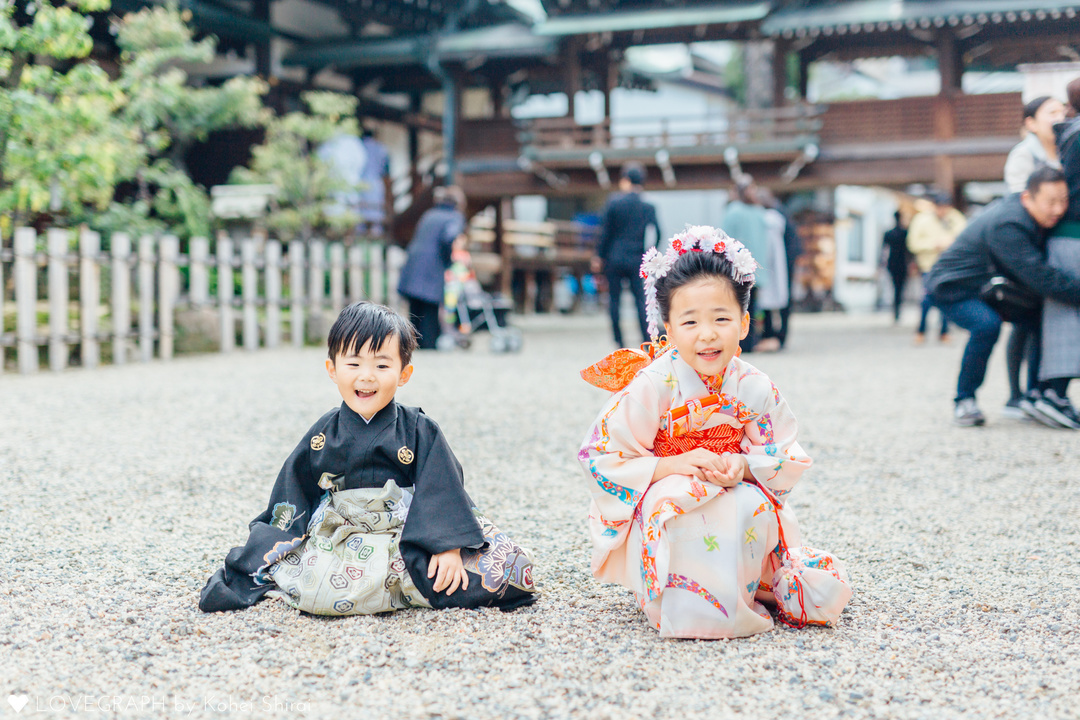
[593,164,661,348]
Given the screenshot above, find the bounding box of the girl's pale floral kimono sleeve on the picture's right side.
[742,382,811,498]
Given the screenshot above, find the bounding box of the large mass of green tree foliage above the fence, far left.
[0,0,267,236]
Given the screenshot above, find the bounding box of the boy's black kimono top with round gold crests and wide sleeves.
[199,402,535,612]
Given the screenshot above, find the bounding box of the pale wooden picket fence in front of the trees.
[0,228,405,372]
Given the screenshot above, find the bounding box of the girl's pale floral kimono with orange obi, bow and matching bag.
[578,349,851,638]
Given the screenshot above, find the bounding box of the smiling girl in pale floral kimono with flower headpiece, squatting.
[578,227,851,638]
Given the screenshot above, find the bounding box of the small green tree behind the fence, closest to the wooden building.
[231,92,361,240]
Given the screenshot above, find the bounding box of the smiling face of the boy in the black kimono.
[326,336,413,420]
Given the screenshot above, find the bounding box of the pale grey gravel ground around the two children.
[0,315,1080,720]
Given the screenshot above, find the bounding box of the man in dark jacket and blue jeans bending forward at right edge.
[927,167,1080,425]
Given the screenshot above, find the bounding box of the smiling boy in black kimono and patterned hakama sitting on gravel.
[199,302,535,615]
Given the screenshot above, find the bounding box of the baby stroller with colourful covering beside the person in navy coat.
[436,246,524,353]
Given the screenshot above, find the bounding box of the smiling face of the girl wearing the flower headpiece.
[664,277,750,376]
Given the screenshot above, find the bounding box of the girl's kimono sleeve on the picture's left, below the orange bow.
[578,375,662,521]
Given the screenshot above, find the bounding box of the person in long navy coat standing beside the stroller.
[397,185,465,350]
